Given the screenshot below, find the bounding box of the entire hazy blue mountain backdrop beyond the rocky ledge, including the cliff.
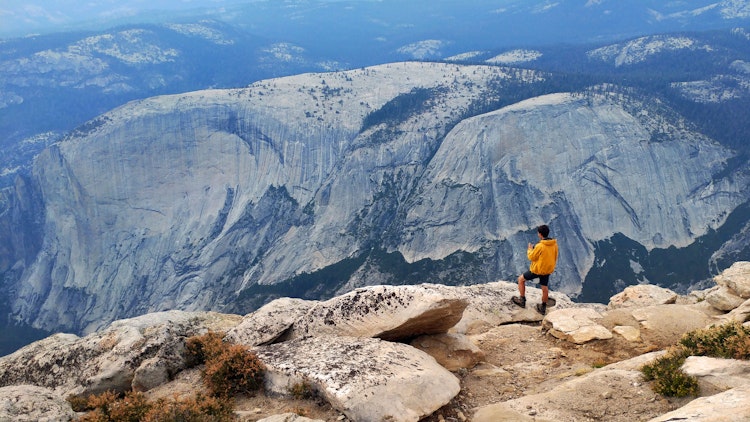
[0,1,750,354]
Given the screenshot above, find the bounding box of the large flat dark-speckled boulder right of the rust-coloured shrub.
[253,336,461,422]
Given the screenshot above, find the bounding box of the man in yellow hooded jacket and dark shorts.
[511,224,557,315]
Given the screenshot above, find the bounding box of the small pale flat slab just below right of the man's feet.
[542,308,613,344]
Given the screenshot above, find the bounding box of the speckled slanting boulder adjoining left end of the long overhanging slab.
[224,297,318,347]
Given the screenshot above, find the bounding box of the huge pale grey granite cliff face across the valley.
[9,63,748,332]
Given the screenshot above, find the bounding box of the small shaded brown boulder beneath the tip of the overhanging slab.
[410,333,485,372]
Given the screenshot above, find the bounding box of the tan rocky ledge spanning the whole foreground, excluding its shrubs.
[0,262,750,422]
